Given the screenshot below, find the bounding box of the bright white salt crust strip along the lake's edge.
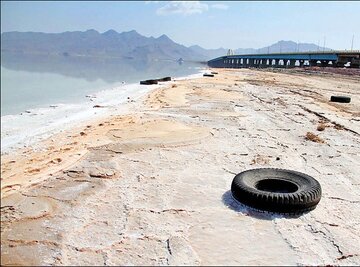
[1,70,203,155]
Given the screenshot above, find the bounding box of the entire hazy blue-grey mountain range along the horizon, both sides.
[1,30,329,61]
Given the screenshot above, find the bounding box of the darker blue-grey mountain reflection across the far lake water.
[1,53,205,83]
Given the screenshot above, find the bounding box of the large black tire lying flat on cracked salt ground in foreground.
[231,168,321,214]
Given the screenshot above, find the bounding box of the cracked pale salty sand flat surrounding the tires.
[1,69,360,265]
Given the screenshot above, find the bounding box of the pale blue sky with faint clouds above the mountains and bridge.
[1,1,360,50]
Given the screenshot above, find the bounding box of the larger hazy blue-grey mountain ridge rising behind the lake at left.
[1,30,207,60]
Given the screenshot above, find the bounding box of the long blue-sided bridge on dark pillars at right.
[208,50,360,68]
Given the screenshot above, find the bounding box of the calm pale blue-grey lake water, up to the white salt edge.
[1,53,204,116]
